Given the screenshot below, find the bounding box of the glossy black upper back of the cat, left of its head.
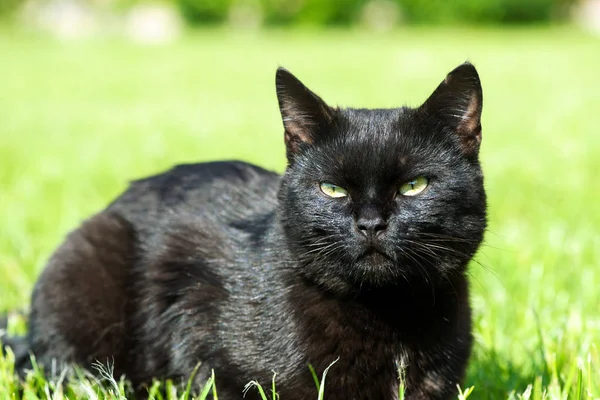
[107,161,279,231]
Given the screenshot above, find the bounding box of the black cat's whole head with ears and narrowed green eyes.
[276,63,486,292]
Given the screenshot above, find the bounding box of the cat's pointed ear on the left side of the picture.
[275,67,334,163]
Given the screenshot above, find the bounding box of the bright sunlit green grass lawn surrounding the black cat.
[0,25,600,400]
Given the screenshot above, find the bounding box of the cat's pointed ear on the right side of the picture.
[421,62,483,156]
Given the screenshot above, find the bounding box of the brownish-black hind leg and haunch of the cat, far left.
[28,212,135,374]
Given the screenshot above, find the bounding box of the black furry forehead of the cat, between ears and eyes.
[309,108,451,181]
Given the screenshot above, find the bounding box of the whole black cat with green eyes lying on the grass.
[1,63,486,400]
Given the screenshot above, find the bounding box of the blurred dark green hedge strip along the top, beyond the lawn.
[0,0,580,26]
